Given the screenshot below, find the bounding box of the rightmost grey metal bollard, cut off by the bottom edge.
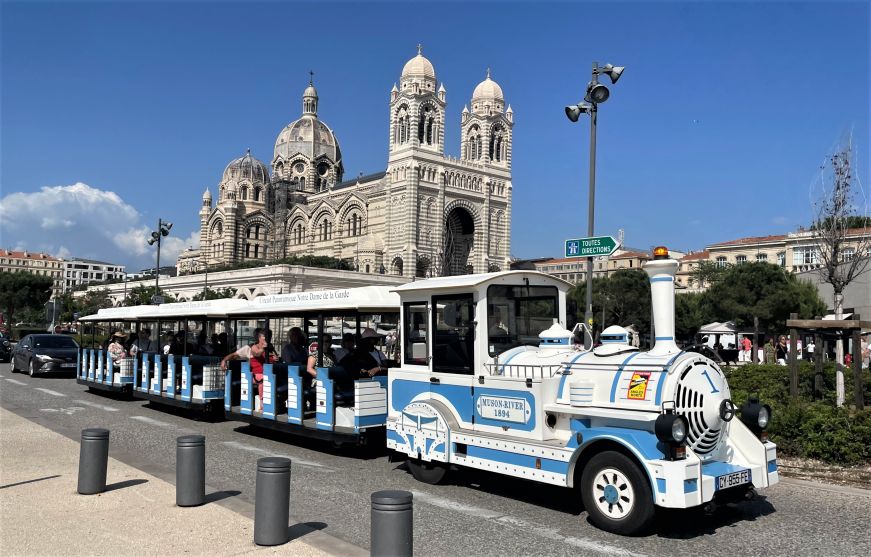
[369,490,414,557]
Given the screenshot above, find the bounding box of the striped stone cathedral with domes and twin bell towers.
[178,46,514,278]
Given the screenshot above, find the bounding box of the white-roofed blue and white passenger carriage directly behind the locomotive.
[224,286,399,445]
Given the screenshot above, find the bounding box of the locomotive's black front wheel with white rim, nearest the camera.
[581,451,654,536]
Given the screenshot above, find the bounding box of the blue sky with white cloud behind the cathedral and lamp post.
[0,2,871,268]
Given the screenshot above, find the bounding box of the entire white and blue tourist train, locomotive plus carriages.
[77,248,778,535]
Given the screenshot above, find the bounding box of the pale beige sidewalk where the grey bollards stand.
[0,408,344,557]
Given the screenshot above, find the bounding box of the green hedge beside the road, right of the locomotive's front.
[725,363,871,465]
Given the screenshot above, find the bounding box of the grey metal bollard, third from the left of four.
[254,456,290,545]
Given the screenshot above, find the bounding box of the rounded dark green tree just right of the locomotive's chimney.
[703,263,826,331]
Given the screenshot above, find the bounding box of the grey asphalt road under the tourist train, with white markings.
[0,364,871,557]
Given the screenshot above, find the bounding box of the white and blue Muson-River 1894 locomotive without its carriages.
[387,248,778,534]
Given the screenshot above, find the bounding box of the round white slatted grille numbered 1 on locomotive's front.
[674,362,729,456]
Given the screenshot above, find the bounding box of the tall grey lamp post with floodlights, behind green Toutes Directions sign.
[565,62,625,346]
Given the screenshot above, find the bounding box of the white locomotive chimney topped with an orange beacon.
[644,247,680,356]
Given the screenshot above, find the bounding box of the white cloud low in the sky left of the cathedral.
[0,182,199,270]
